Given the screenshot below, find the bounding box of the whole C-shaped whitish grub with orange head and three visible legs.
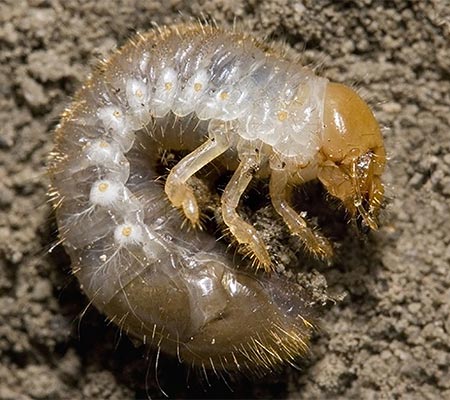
[49,23,386,371]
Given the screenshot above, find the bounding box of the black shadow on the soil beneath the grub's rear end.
[81,310,307,399]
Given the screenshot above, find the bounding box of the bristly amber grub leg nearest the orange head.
[269,169,333,259]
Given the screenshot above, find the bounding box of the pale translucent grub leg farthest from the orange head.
[165,137,228,226]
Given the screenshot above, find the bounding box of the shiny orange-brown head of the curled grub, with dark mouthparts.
[319,83,386,229]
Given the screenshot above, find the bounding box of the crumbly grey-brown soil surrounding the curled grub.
[0,0,450,400]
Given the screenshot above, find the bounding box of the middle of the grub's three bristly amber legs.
[222,155,271,271]
